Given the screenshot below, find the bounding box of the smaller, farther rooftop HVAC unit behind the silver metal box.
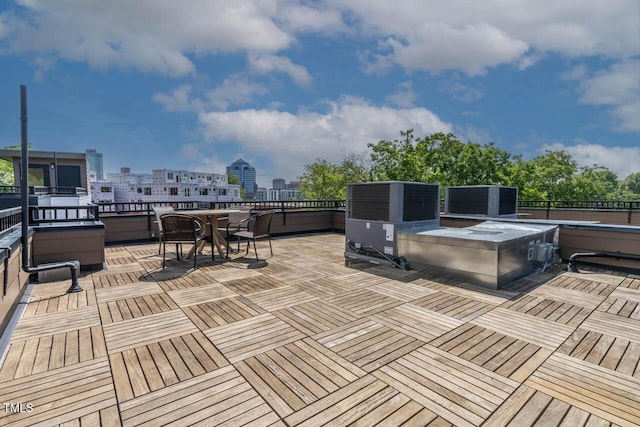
[444,185,518,218]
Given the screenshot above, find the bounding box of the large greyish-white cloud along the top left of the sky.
[1,0,294,76]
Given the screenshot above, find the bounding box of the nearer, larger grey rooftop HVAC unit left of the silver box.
[345,181,440,265]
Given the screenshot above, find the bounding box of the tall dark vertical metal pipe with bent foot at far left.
[20,85,82,292]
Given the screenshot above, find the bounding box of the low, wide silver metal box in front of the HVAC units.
[398,221,557,289]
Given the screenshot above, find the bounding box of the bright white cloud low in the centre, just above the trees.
[199,97,452,179]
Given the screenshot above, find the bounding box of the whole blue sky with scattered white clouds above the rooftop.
[0,0,640,187]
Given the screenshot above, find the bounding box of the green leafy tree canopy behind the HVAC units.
[300,129,640,200]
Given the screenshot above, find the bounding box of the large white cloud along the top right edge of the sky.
[329,0,640,75]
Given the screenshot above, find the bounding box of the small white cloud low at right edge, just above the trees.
[541,143,640,179]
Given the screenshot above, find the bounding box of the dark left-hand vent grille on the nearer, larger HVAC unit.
[348,184,389,221]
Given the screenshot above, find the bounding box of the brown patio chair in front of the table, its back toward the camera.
[160,213,213,269]
